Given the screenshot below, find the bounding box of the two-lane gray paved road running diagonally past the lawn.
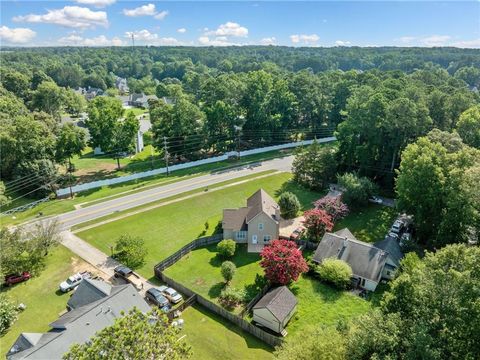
[31,156,293,230]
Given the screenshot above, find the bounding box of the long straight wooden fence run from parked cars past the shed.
[159,269,283,347]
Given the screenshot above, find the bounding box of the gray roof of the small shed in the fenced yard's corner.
[253,286,297,322]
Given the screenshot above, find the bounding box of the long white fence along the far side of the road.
[57,136,336,196]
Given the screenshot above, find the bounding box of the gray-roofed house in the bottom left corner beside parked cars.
[7,279,150,360]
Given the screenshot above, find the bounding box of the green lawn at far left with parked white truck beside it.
[0,245,90,355]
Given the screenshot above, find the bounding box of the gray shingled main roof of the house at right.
[313,233,388,282]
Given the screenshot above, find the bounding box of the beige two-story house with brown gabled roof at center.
[222,189,281,252]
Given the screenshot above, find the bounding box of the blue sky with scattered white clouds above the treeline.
[0,0,480,48]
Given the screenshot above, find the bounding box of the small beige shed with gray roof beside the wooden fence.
[253,286,297,336]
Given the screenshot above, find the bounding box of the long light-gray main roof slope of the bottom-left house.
[7,281,150,360]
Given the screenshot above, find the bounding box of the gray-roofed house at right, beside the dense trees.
[313,229,403,291]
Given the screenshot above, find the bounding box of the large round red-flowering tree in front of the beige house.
[260,240,308,285]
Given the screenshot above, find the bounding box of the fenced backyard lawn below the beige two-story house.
[165,244,265,311]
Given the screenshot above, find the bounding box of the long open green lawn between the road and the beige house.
[77,173,320,278]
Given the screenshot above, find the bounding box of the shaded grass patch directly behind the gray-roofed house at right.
[334,204,397,243]
